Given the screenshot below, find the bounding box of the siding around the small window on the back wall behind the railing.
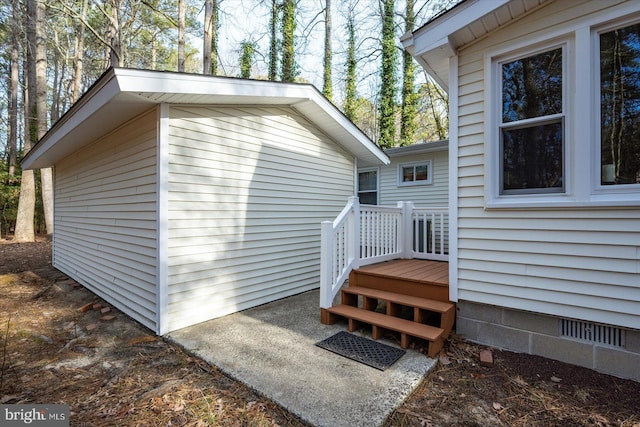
[378,150,449,207]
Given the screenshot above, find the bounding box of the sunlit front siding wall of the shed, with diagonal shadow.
[167,106,354,330]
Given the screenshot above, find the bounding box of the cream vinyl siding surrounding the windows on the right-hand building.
[457,1,640,329]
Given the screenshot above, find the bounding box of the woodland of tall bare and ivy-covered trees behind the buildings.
[0,0,456,242]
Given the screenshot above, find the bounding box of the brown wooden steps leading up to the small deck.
[321,270,455,357]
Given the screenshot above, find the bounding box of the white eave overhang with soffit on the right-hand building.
[400,0,548,92]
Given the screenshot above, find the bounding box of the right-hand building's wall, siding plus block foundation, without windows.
[452,1,640,379]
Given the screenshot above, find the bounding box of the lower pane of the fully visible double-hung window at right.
[502,121,563,191]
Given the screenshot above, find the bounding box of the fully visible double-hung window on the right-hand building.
[498,46,566,195]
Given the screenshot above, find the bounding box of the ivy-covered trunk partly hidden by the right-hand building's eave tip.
[400,0,418,145]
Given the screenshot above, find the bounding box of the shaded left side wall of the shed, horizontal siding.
[53,110,157,330]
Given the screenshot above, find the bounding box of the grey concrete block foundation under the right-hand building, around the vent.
[456,301,640,381]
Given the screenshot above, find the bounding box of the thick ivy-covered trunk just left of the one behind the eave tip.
[378,0,396,148]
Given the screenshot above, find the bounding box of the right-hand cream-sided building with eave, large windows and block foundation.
[402,0,640,380]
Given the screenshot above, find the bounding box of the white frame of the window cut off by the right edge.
[590,14,640,205]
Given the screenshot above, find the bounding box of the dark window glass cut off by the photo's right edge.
[600,24,640,185]
